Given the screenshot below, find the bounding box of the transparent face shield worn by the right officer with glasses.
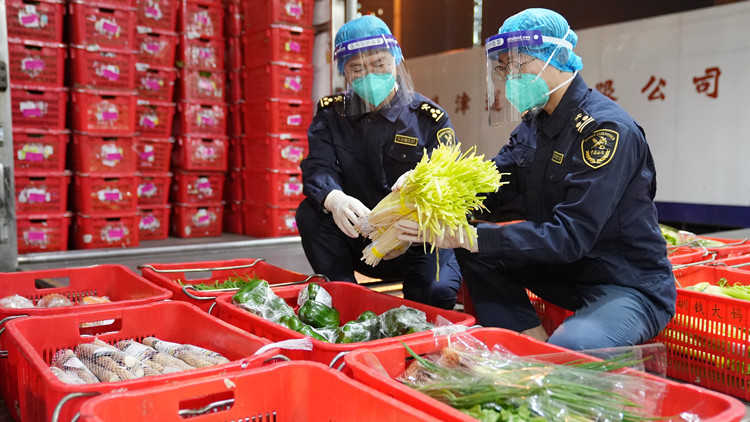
[485,29,577,126]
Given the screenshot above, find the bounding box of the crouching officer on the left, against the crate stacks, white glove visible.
[296,16,461,309]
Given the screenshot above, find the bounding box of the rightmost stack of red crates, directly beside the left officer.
[234,0,315,237]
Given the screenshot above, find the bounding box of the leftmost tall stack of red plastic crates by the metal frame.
[5,0,71,254]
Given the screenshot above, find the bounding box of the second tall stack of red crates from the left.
[67,0,139,249]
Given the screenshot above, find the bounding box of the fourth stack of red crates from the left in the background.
[170,0,229,237]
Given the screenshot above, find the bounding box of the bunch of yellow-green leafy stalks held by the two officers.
[360,143,507,266]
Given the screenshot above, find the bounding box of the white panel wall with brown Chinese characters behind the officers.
[407,2,750,206]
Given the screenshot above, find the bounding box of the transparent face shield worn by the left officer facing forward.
[334,35,414,116]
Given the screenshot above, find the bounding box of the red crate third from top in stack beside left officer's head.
[244,62,313,100]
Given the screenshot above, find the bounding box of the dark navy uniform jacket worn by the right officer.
[478,76,677,313]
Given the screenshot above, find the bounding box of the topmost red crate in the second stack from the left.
[68,2,136,50]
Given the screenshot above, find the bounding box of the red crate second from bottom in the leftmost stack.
[15,171,71,215]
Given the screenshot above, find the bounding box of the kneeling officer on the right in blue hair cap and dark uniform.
[397,9,677,350]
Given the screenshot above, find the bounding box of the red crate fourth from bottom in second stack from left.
[73,89,137,136]
